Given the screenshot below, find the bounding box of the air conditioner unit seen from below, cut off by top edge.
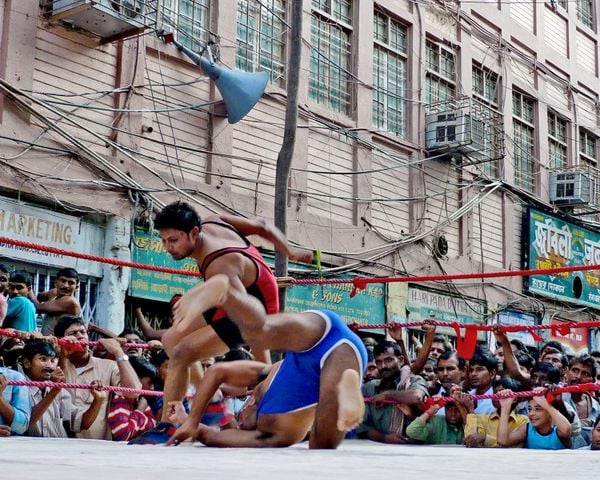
[49,0,146,38]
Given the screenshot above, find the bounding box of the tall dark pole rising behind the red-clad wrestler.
[275,0,304,310]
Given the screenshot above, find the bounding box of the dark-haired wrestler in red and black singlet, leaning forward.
[131,202,312,444]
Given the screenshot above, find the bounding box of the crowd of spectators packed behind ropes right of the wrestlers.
[355,325,600,450]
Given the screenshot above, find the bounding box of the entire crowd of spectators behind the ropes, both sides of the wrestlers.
[0,265,600,450]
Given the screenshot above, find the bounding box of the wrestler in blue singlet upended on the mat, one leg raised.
[162,275,367,448]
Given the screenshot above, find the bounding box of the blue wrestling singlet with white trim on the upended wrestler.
[257,310,367,415]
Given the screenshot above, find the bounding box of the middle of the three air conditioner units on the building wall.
[425,110,487,153]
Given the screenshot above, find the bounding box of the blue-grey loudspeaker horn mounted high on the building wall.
[173,40,269,123]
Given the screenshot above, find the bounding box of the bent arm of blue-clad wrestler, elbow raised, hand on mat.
[167,360,271,445]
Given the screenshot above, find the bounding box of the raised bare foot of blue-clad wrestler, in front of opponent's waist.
[173,274,229,329]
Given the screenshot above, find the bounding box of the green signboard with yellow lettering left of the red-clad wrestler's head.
[129,230,202,302]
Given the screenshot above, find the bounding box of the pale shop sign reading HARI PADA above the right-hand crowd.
[406,285,487,340]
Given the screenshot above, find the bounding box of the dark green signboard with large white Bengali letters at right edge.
[524,209,600,308]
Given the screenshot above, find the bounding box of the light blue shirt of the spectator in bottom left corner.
[0,367,31,435]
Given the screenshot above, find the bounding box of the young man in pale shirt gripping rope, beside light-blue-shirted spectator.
[21,340,107,438]
